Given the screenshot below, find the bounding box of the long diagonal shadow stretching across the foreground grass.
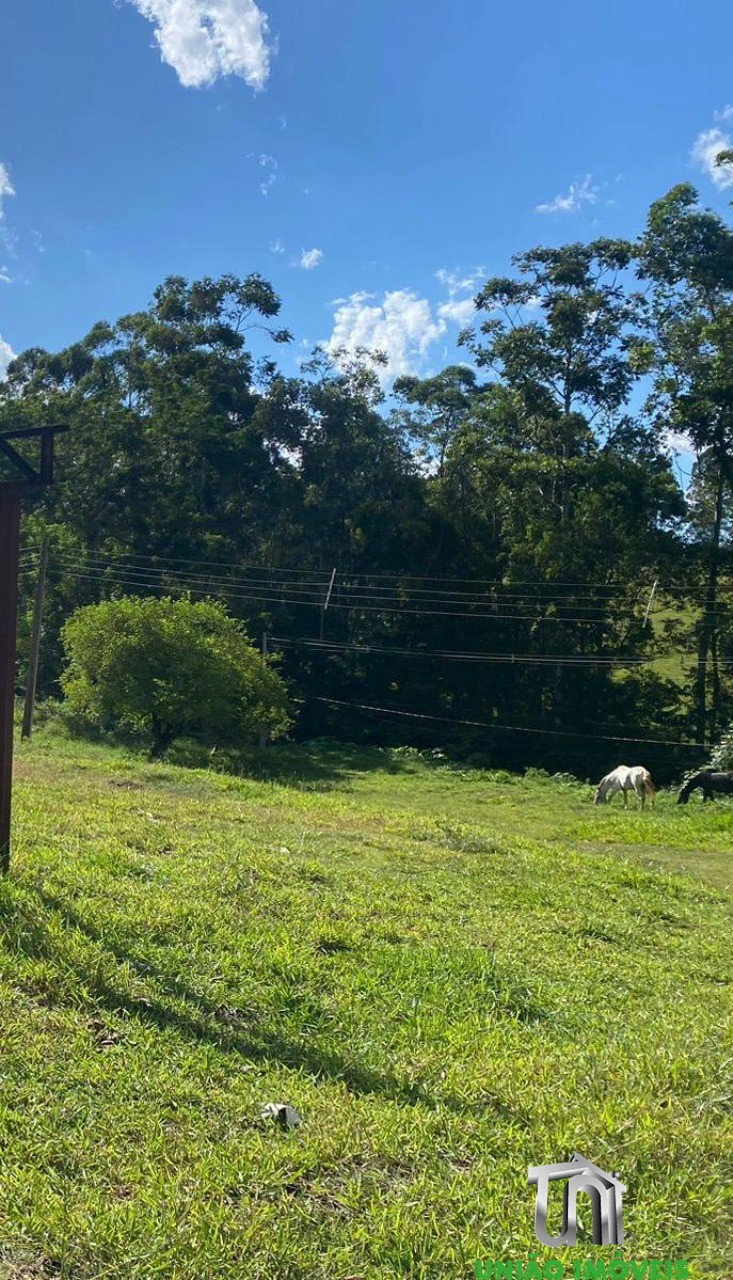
[0,886,528,1126]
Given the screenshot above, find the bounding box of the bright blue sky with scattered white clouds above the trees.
[0,0,733,389]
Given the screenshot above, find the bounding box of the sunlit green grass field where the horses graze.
[0,728,733,1280]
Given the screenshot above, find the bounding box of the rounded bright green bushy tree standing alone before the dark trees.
[61,598,290,759]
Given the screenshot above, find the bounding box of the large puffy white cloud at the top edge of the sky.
[130,0,270,88]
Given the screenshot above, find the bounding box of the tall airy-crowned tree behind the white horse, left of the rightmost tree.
[446,239,682,747]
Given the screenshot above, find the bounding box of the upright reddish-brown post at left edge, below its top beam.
[0,489,20,876]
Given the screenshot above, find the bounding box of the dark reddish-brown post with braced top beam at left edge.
[0,426,68,874]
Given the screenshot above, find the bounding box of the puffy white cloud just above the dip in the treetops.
[325,289,446,383]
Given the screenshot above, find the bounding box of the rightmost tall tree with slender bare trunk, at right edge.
[636,184,733,741]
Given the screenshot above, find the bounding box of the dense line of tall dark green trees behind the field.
[0,186,733,772]
